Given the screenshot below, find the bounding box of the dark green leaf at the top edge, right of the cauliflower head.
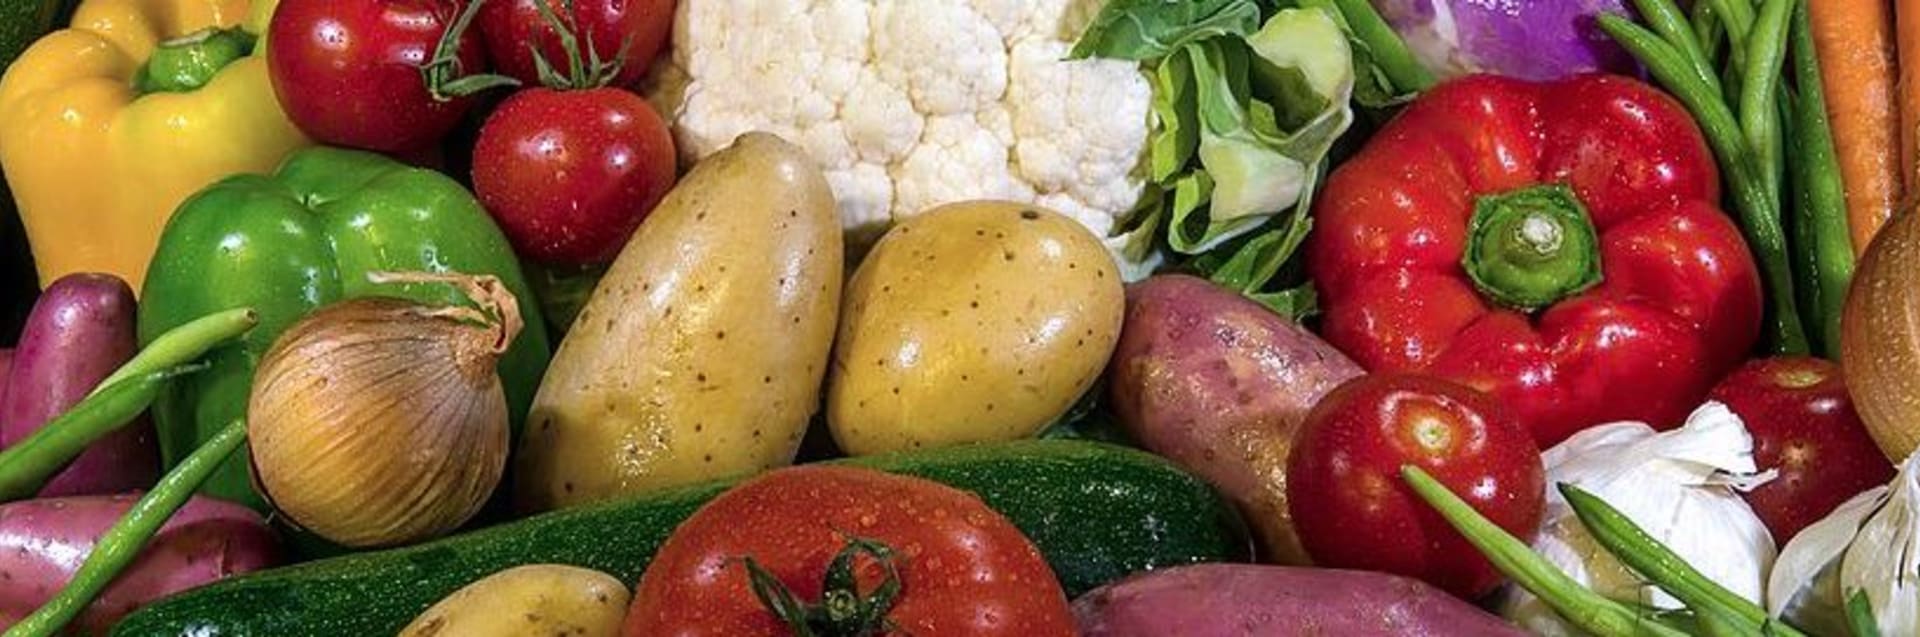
[1068,0,1261,61]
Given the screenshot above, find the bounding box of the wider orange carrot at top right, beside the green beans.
[1807,0,1920,253]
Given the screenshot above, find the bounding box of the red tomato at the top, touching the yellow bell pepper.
[267,0,486,153]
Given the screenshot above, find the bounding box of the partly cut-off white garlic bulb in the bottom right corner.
[1766,453,1920,635]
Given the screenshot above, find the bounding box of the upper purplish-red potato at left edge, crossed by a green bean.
[0,274,159,497]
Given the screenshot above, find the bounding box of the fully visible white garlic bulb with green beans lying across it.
[1501,403,1774,635]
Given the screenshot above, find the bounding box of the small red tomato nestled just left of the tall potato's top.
[474,88,676,265]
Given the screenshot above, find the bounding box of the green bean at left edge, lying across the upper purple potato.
[0,366,196,503]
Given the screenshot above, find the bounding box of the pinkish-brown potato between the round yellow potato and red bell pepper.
[1108,276,1361,564]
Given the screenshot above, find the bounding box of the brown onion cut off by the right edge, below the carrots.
[1839,213,1920,462]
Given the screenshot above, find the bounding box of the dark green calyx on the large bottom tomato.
[741,535,902,637]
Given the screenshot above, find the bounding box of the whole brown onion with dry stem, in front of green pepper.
[248,274,522,547]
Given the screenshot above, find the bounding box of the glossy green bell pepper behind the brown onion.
[140,148,551,508]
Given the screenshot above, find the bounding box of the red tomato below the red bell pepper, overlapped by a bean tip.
[1286,374,1546,599]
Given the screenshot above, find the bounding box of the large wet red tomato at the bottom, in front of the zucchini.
[624,466,1073,637]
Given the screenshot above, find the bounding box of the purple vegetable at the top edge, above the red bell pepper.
[1373,0,1638,81]
